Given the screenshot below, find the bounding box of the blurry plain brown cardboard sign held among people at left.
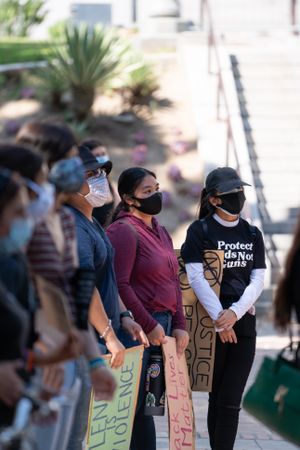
[34,275,73,334]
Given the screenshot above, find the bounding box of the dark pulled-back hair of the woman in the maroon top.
[112,167,156,222]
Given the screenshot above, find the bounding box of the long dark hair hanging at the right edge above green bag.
[274,216,300,331]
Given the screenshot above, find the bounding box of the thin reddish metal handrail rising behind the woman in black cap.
[201,0,239,171]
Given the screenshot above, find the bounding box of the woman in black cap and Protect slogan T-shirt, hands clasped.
[181,167,266,450]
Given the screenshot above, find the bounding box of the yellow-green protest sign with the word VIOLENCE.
[86,345,144,450]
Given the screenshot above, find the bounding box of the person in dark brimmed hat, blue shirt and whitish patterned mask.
[68,145,148,450]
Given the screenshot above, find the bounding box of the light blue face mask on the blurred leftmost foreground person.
[0,218,34,255]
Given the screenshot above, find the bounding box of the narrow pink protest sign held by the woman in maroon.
[162,337,195,450]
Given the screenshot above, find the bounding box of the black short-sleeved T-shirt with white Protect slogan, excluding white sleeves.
[181,216,266,302]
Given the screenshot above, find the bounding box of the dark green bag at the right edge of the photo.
[243,342,300,445]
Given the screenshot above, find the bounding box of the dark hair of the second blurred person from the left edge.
[0,144,43,181]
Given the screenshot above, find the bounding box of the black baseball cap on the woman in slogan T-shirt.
[205,167,251,194]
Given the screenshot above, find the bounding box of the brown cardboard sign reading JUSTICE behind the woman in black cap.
[176,250,224,392]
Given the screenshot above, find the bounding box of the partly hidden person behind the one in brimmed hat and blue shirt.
[82,139,119,228]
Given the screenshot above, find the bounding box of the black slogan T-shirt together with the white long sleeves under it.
[182,214,266,321]
